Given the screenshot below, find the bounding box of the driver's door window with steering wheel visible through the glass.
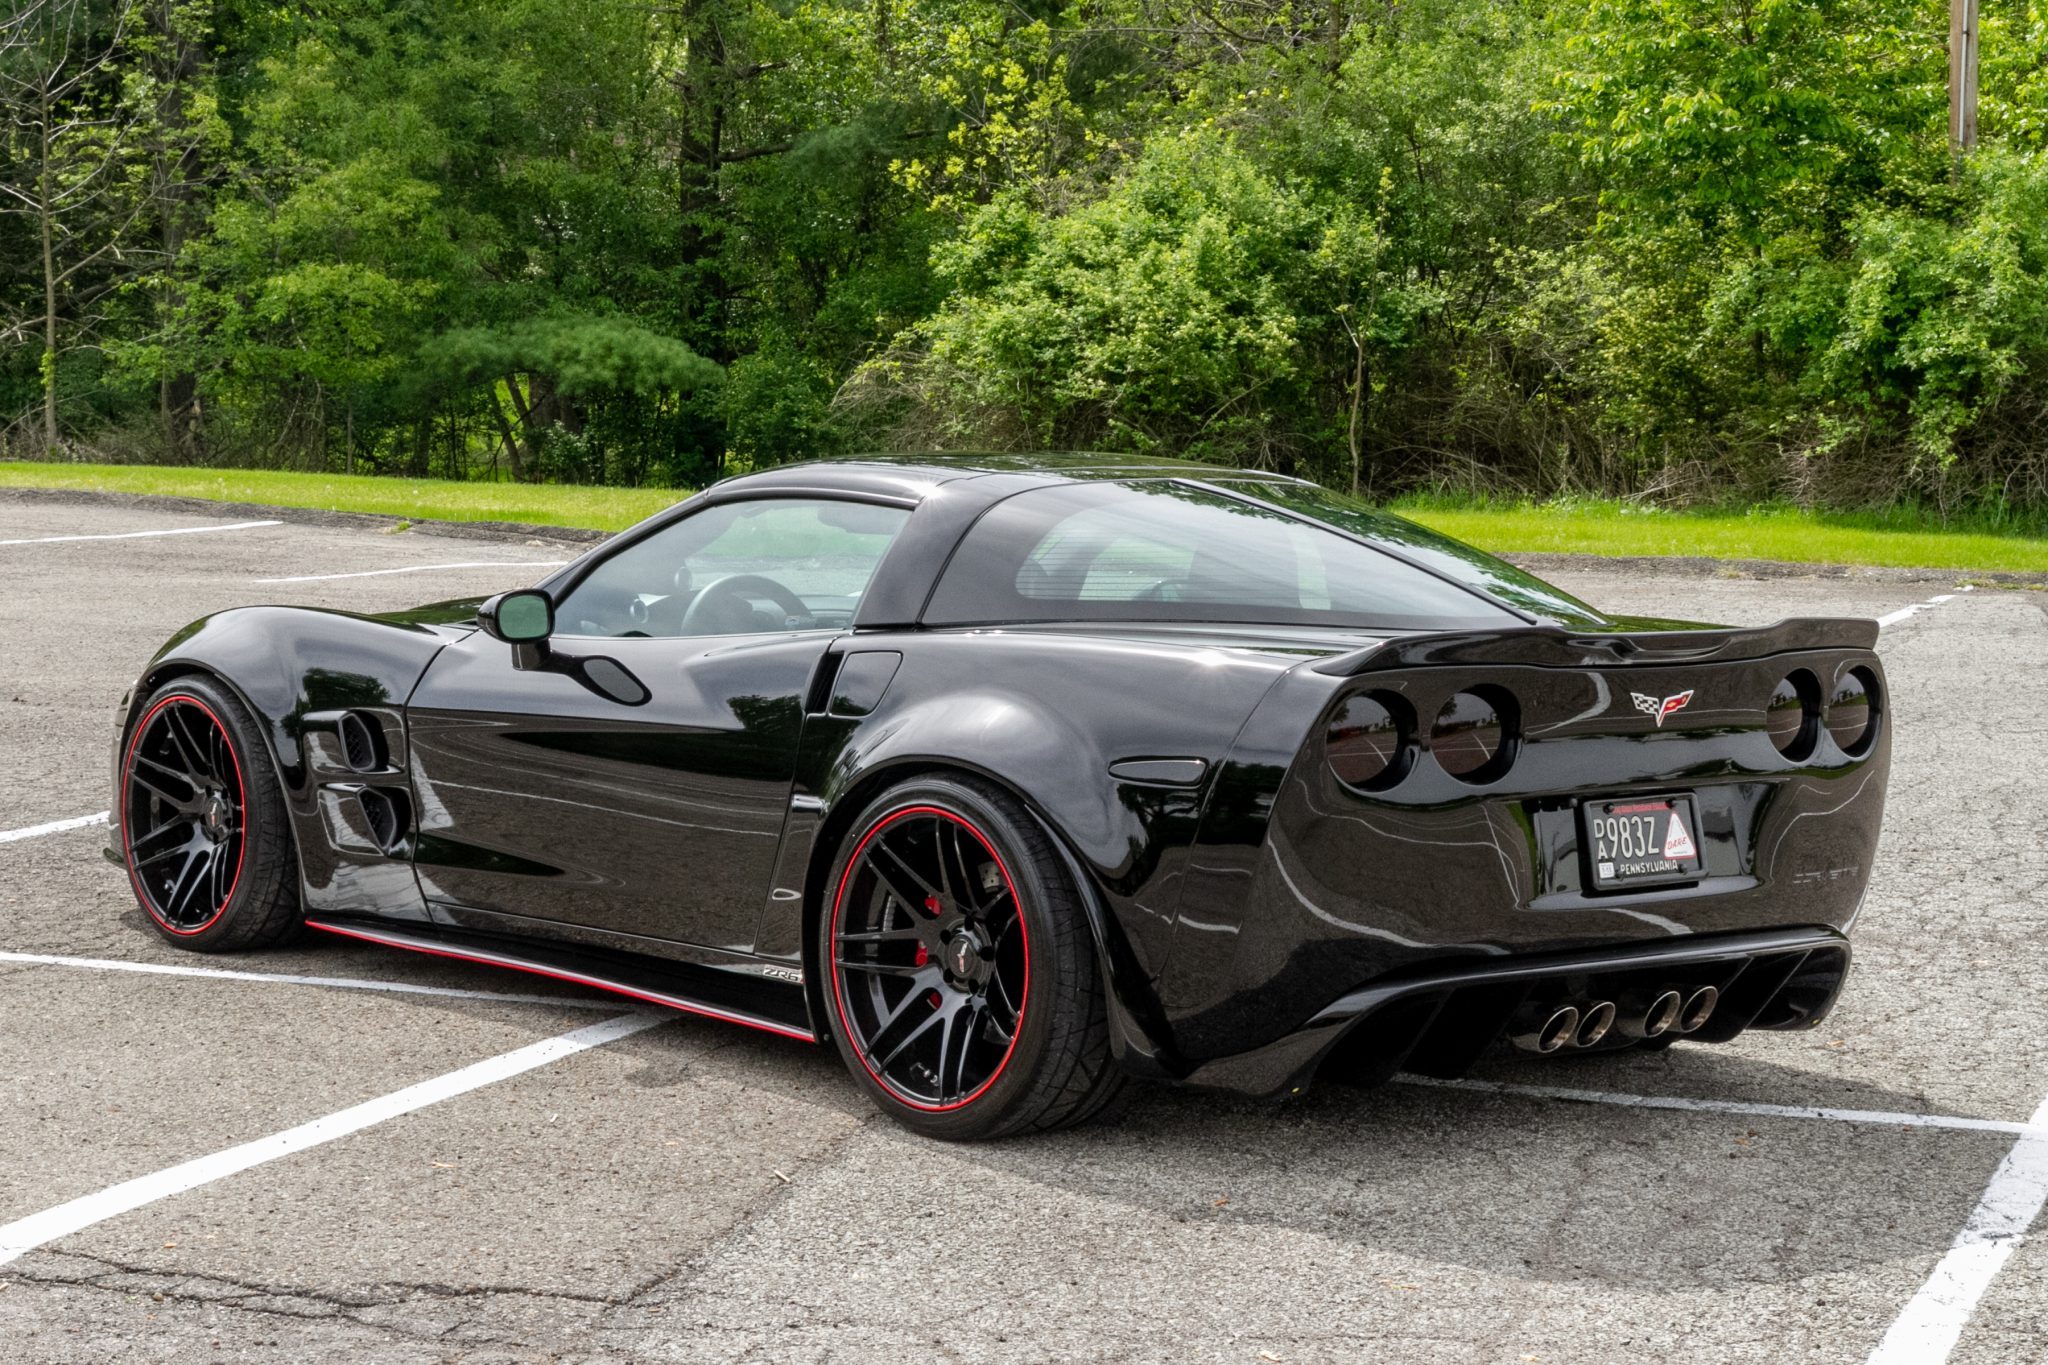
[555,497,909,636]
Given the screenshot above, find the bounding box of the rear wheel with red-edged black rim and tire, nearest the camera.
[815,776,1124,1142]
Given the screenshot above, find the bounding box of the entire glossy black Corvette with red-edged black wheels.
[113,458,1890,1138]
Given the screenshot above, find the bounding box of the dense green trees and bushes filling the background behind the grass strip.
[0,0,2048,520]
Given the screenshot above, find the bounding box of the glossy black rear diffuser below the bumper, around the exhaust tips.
[1184,927,1849,1099]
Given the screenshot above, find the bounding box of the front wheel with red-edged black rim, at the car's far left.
[115,675,303,952]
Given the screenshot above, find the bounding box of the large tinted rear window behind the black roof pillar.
[924,481,1518,628]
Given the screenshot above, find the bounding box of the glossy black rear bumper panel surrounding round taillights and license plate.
[1153,645,1890,1089]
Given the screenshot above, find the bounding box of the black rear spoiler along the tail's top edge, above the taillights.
[1313,616,1878,677]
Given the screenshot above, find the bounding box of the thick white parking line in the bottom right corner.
[1870,1101,2048,1365]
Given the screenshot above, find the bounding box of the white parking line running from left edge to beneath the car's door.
[0,1011,676,1265]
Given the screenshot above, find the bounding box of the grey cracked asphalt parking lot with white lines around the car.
[0,495,2048,1365]
